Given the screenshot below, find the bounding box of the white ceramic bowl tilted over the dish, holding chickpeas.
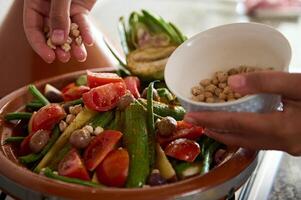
[164,23,291,112]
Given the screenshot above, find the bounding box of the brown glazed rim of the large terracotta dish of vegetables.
[0,68,257,199]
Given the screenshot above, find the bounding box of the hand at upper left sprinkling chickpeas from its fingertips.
[23,0,96,63]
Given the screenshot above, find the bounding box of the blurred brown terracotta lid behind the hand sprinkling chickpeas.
[0,0,116,97]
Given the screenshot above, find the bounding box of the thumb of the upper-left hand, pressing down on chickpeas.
[49,0,71,45]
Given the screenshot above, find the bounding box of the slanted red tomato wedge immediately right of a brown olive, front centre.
[84,130,122,171]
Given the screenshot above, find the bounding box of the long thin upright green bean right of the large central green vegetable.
[147,81,156,169]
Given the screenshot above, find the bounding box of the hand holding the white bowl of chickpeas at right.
[184,72,301,155]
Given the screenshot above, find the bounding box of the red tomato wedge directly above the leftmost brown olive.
[29,104,66,133]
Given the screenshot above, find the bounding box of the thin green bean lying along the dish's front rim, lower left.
[43,167,103,187]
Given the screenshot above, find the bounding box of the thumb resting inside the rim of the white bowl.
[228,71,301,100]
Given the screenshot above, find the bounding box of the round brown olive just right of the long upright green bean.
[156,116,177,137]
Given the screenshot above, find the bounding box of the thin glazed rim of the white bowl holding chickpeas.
[164,22,292,108]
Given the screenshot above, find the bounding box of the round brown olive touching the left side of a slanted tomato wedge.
[69,129,91,149]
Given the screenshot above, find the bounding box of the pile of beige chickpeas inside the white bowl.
[191,66,273,103]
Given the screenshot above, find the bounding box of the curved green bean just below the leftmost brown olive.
[19,126,60,164]
